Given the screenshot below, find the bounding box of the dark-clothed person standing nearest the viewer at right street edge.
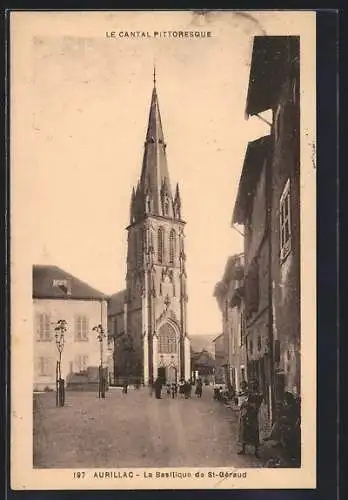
[238,380,263,457]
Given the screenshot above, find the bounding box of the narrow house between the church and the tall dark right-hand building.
[214,254,247,392]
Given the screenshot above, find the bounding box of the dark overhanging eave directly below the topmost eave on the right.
[232,135,271,224]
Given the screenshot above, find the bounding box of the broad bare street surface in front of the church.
[34,388,274,468]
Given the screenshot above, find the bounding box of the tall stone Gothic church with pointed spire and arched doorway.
[108,73,191,384]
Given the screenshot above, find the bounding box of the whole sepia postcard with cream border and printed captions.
[9,10,316,490]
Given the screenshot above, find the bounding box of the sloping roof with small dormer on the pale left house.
[32,265,107,300]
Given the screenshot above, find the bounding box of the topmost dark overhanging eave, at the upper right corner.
[246,36,300,116]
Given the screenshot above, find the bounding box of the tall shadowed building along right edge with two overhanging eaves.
[232,36,301,419]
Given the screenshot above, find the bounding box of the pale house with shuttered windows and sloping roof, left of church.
[32,265,110,390]
